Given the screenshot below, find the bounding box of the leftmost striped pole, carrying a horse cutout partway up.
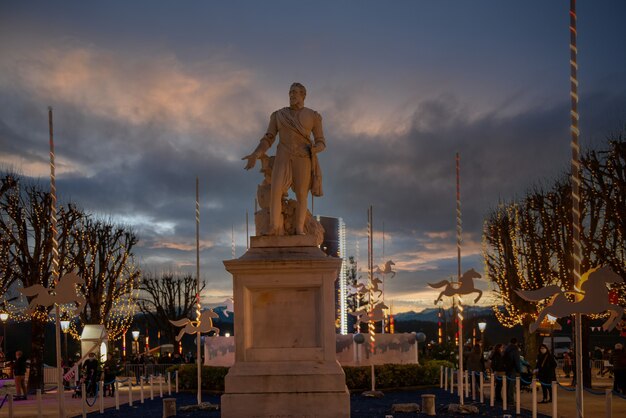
[48,107,65,418]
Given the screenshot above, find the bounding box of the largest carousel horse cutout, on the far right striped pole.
[515,266,624,332]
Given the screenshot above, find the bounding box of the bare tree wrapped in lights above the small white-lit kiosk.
[70,217,141,341]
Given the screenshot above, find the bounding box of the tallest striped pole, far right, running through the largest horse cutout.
[569,0,584,418]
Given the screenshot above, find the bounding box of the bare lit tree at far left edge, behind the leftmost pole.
[0,174,83,389]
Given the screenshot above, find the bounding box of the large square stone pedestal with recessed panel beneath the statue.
[221,236,350,418]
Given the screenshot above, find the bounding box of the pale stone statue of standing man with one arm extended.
[242,83,326,235]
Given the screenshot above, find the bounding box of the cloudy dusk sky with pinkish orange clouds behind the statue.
[0,0,626,310]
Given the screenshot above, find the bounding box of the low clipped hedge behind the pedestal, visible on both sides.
[168,360,452,392]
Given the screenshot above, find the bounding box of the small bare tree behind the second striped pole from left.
[138,273,206,344]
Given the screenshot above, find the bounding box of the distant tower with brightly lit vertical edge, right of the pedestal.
[316,215,348,335]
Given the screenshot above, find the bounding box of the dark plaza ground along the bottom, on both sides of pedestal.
[0,370,626,418]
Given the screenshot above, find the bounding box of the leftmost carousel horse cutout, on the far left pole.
[20,272,87,315]
